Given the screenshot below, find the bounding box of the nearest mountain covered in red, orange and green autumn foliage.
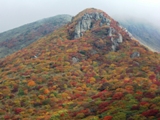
[0,8,160,120]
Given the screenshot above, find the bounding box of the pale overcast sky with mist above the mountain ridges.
[0,0,160,32]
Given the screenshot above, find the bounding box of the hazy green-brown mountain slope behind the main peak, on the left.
[0,15,72,58]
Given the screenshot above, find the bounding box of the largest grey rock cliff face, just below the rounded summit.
[74,12,110,39]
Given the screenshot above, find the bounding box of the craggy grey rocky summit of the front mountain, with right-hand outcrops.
[68,9,123,51]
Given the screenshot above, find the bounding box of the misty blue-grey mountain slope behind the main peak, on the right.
[119,19,160,52]
